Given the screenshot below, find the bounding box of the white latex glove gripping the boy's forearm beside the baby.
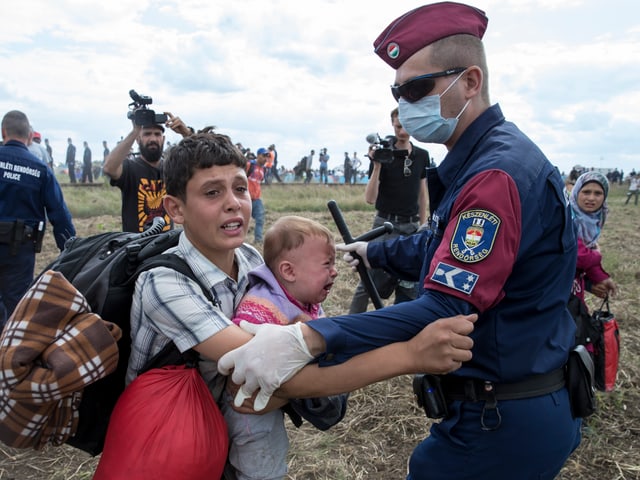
[218,321,313,411]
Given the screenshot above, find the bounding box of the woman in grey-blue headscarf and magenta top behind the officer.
[569,172,617,303]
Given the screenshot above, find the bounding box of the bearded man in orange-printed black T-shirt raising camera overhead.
[104,90,193,232]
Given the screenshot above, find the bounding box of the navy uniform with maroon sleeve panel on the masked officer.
[309,105,580,480]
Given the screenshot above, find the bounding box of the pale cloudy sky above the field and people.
[0,0,640,173]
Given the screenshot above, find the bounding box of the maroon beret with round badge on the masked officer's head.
[373,2,489,69]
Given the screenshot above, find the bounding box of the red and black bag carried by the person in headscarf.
[591,298,620,392]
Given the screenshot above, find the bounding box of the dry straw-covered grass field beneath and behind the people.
[0,182,640,480]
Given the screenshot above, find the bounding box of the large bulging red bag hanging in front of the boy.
[93,365,229,480]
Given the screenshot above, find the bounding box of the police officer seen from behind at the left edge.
[0,110,76,328]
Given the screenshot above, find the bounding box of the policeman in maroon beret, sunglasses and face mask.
[220,2,581,480]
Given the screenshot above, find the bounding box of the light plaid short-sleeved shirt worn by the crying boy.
[127,232,263,390]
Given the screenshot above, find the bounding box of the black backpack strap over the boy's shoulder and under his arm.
[133,253,217,375]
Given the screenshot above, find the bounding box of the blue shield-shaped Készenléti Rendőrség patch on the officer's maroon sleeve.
[451,210,501,263]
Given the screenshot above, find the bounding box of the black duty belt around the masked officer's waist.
[441,368,565,402]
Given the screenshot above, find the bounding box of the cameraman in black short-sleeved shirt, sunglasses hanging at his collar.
[349,108,429,313]
